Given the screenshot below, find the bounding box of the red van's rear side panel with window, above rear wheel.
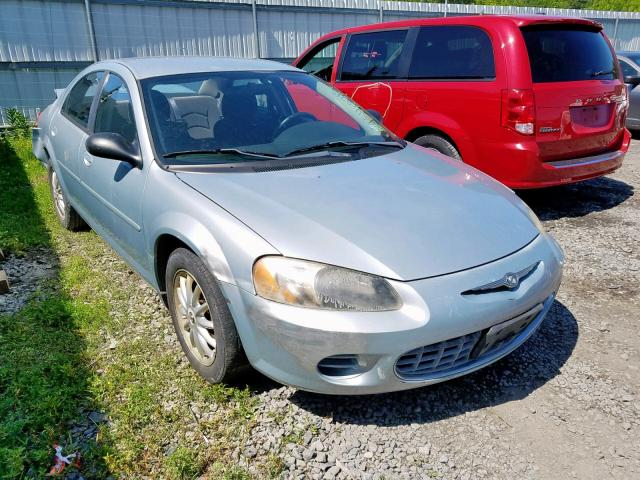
[398,25,505,164]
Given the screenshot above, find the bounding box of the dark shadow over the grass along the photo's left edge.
[0,138,108,479]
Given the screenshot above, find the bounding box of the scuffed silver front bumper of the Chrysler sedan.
[223,234,563,394]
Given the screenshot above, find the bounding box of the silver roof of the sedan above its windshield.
[93,57,298,79]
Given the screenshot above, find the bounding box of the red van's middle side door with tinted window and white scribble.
[335,29,409,130]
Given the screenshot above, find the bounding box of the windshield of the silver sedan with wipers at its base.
[141,71,403,164]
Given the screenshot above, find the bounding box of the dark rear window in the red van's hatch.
[522,25,618,83]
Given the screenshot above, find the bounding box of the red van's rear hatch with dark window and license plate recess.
[521,23,626,161]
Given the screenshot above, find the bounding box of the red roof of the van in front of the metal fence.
[323,15,602,38]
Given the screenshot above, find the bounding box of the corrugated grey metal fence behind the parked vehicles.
[0,0,640,125]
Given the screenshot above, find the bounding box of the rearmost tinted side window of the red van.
[409,26,496,80]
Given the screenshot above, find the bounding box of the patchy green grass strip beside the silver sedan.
[0,135,264,480]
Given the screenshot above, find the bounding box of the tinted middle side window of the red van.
[340,30,407,80]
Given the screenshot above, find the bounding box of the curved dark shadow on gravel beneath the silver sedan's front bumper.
[291,301,578,426]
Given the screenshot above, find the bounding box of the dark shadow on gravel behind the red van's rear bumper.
[517,177,634,220]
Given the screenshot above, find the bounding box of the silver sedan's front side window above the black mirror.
[93,74,137,142]
